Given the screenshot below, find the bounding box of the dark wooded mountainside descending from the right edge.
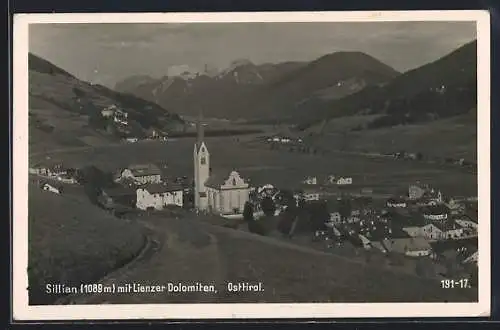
[295,41,477,129]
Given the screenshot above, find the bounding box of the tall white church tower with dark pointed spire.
[193,112,210,211]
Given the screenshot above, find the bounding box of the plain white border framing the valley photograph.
[12,11,491,321]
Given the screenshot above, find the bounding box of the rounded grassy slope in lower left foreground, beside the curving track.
[28,183,145,305]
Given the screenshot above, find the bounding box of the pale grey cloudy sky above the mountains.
[29,22,476,88]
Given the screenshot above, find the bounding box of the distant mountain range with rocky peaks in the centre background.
[115,52,399,120]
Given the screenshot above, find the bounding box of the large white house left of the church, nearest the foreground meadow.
[136,183,184,210]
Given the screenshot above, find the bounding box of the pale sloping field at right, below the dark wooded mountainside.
[309,113,477,162]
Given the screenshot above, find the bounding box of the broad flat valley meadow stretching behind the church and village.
[31,133,477,195]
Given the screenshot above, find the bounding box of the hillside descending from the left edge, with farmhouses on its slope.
[28,53,183,148]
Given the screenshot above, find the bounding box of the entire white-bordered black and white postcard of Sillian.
[12,11,490,320]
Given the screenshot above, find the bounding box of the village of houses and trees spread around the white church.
[29,114,478,284]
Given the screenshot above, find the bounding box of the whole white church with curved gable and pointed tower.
[193,116,250,215]
